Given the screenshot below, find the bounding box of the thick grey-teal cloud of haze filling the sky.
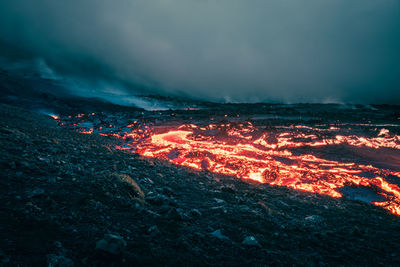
[0,0,400,103]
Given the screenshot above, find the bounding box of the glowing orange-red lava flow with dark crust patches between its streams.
[57,114,400,215]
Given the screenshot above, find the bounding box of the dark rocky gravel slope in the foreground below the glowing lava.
[0,105,400,266]
